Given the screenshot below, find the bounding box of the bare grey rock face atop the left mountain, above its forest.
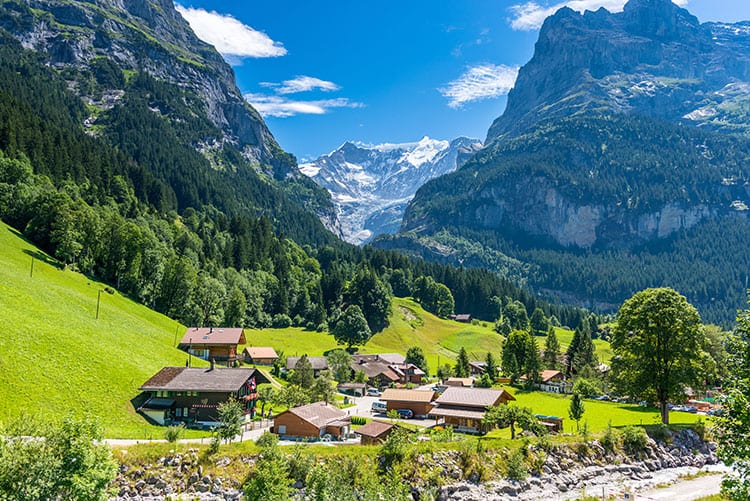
[0,0,298,174]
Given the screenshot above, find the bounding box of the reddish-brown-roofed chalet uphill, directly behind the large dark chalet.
[178,327,246,366]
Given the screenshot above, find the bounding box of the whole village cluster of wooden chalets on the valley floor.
[134,327,714,445]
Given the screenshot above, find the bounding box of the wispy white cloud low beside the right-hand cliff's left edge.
[438,64,518,108]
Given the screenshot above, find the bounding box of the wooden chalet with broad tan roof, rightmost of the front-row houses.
[429,386,515,433]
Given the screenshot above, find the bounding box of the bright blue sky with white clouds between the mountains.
[177,0,750,160]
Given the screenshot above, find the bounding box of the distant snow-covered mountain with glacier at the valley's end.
[300,137,481,244]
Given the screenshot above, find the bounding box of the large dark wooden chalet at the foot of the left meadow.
[138,366,269,426]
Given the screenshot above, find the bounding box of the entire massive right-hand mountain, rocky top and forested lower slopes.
[375,0,750,324]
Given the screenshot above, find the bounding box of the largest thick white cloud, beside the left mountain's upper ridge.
[175,4,286,58]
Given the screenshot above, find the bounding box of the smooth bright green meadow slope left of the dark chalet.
[0,223,206,438]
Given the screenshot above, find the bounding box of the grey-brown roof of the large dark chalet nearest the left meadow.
[139,367,269,392]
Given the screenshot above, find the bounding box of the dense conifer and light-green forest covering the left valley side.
[0,2,588,329]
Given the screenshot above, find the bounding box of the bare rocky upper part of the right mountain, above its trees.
[487,0,750,143]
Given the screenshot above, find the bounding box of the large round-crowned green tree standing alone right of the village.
[612,288,706,424]
